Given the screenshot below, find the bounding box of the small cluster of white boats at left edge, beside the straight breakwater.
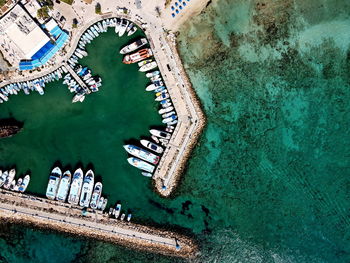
[0,168,30,193]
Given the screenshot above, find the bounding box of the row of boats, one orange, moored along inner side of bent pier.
[120,38,177,177]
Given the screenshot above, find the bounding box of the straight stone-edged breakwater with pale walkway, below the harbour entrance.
[0,189,197,258]
